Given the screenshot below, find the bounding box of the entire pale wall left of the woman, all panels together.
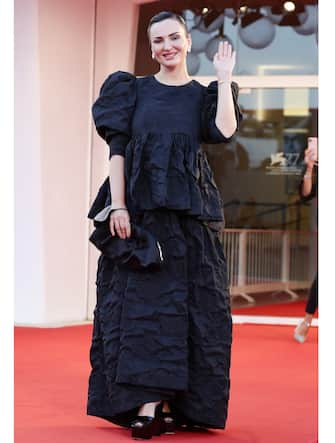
[15,0,138,326]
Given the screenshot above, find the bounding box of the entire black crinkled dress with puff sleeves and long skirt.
[87,71,241,428]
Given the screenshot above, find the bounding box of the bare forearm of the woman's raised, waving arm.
[215,81,237,138]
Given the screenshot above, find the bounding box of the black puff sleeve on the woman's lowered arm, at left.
[92,71,136,158]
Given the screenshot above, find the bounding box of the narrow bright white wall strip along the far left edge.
[14,0,45,323]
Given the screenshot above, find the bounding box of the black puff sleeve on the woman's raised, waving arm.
[201,81,242,143]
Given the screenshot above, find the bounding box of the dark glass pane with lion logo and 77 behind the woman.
[203,88,318,230]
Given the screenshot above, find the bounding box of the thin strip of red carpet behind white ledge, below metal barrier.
[232,300,318,318]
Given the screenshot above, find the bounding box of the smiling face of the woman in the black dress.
[150,18,191,68]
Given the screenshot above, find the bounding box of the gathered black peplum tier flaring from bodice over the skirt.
[89,133,223,222]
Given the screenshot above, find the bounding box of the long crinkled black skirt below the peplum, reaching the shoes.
[87,210,232,428]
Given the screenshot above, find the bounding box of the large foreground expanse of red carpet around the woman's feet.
[15,325,318,443]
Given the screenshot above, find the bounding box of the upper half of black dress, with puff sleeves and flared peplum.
[90,71,241,225]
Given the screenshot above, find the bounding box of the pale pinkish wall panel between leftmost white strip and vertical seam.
[39,0,95,322]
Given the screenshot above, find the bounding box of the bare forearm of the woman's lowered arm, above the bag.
[109,155,126,208]
